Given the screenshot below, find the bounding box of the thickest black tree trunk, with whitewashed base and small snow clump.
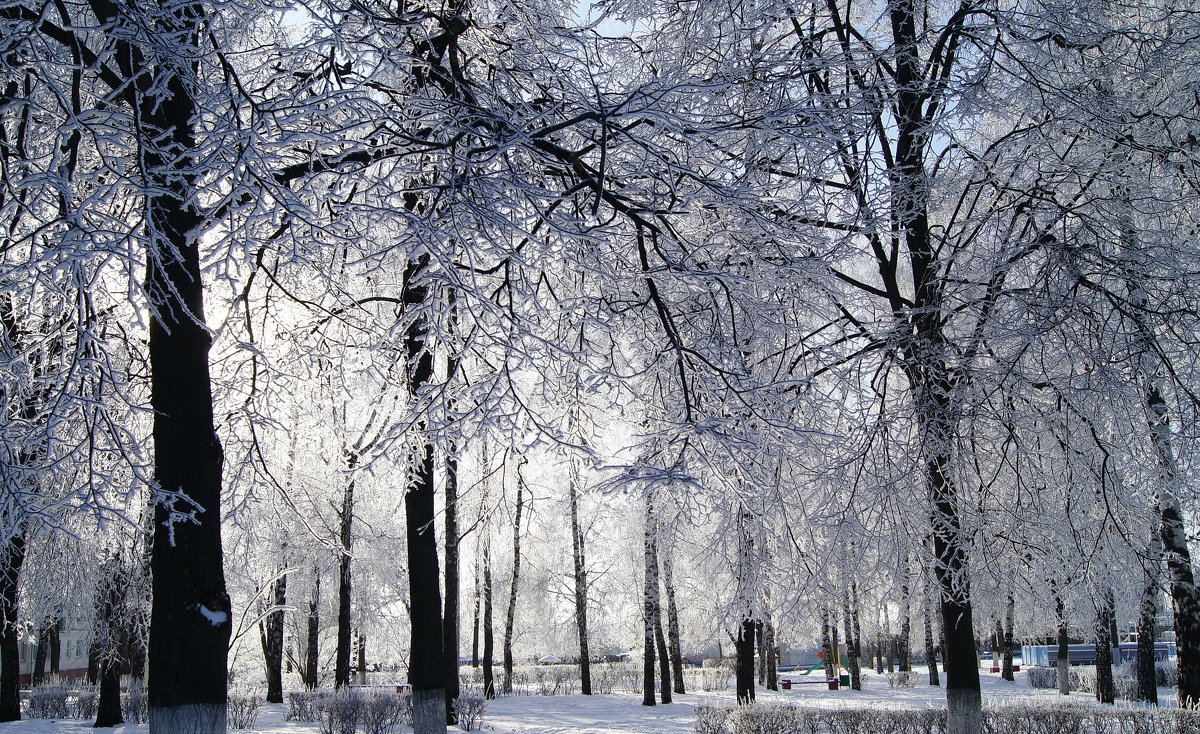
[132,4,233,734]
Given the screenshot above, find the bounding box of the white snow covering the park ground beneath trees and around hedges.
[0,670,1175,734]
